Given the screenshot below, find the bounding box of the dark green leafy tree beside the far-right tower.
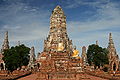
[87,44,108,67]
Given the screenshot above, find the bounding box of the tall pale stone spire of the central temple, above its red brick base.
[44,6,72,52]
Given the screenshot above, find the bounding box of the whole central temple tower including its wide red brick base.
[37,6,82,80]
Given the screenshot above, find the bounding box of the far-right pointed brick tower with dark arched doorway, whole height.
[108,33,119,71]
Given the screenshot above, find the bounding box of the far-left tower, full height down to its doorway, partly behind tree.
[0,31,9,70]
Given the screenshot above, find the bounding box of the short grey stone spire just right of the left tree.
[28,47,36,68]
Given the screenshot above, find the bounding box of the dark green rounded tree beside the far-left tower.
[3,44,30,71]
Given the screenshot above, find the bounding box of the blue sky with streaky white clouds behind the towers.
[0,0,120,55]
